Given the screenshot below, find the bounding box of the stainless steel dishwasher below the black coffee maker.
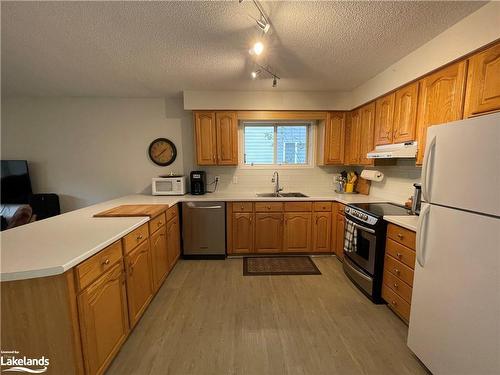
[182,201,226,258]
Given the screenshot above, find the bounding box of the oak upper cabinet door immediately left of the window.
[215,112,238,165]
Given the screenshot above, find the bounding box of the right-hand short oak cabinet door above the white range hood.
[392,82,419,143]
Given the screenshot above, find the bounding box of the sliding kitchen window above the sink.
[242,122,312,167]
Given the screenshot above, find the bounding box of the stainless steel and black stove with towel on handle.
[344,203,410,303]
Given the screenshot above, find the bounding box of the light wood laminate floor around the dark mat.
[107,257,427,375]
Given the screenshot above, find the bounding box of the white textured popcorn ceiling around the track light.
[1,0,484,97]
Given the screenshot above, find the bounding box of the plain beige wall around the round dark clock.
[1,98,193,211]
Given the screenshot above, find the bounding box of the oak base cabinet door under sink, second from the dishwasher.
[254,212,283,253]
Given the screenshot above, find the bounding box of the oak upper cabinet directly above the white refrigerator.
[464,43,500,118]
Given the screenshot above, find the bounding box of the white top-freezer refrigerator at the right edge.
[408,113,500,375]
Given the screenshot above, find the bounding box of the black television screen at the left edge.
[0,160,31,203]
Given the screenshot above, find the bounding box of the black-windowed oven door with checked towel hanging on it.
[344,217,377,276]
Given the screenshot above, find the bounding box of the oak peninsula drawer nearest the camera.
[75,241,122,290]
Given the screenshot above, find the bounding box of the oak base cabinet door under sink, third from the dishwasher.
[284,212,312,252]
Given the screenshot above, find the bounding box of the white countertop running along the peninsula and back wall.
[0,191,402,281]
